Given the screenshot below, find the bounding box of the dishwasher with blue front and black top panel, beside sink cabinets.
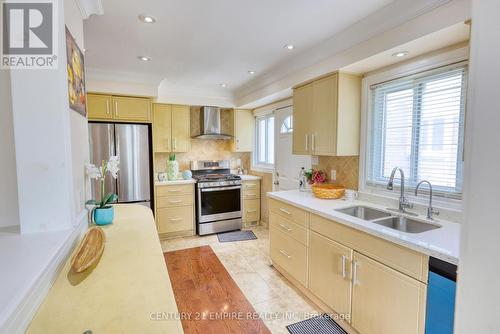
[425,257,457,334]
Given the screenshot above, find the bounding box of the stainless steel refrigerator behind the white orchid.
[89,123,151,207]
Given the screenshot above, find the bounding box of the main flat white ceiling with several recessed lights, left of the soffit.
[84,0,393,96]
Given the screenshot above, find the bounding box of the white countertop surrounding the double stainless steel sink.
[267,190,460,264]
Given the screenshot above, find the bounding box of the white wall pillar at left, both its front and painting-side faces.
[10,0,89,233]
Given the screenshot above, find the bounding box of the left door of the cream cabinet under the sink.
[309,232,353,315]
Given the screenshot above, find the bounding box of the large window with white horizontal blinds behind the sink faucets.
[365,64,467,199]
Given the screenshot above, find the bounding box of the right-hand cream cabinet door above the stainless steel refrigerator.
[113,96,151,122]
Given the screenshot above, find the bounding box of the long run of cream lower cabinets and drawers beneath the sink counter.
[269,199,428,334]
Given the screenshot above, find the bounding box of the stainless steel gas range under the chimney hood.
[191,160,243,235]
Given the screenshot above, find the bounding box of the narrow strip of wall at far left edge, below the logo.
[0,70,19,227]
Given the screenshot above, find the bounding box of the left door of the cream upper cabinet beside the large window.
[292,84,313,154]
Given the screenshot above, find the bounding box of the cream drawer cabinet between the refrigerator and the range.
[155,184,195,238]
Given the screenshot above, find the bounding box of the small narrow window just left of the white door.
[254,114,274,168]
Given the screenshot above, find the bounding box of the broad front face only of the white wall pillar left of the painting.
[11,2,74,233]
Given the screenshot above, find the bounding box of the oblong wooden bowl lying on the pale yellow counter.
[71,226,106,273]
